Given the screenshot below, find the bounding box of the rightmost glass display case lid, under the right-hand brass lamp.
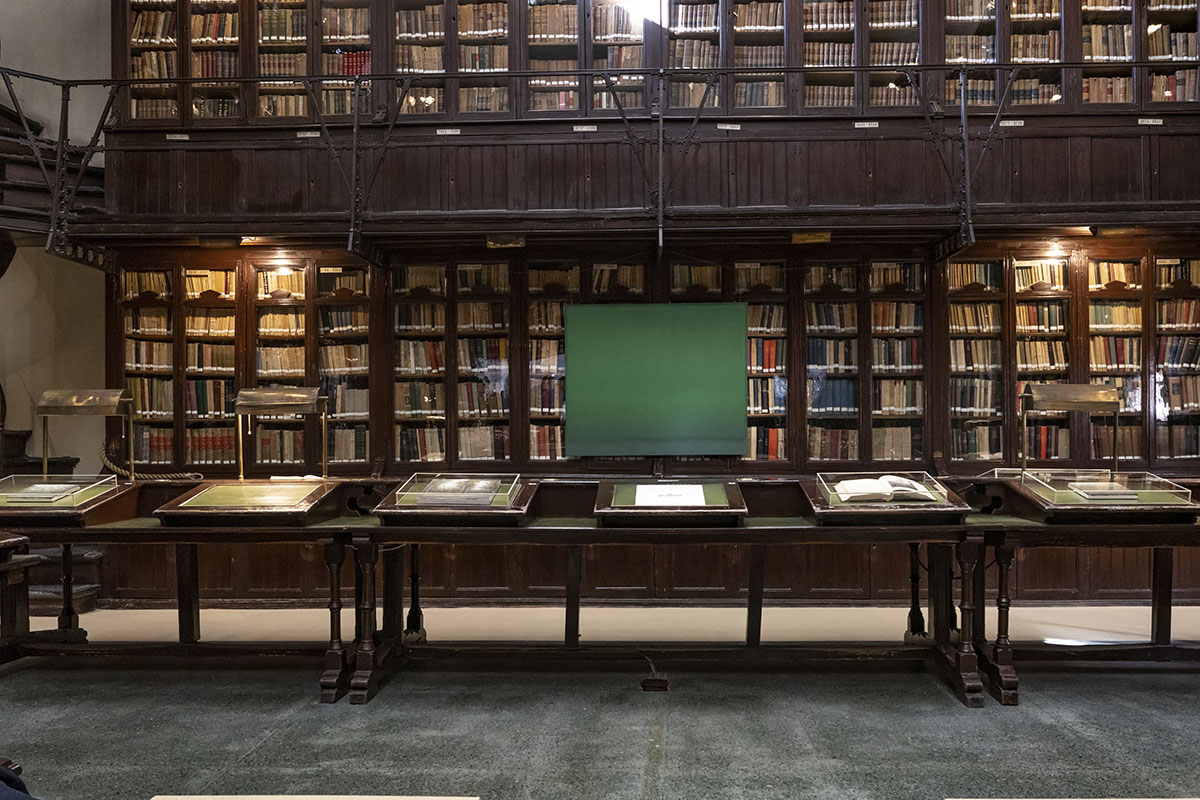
[1015,469,1192,506]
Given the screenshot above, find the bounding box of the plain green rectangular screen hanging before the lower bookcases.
[565,302,746,456]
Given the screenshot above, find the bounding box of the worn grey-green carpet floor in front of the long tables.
[0,663,1200,800]
